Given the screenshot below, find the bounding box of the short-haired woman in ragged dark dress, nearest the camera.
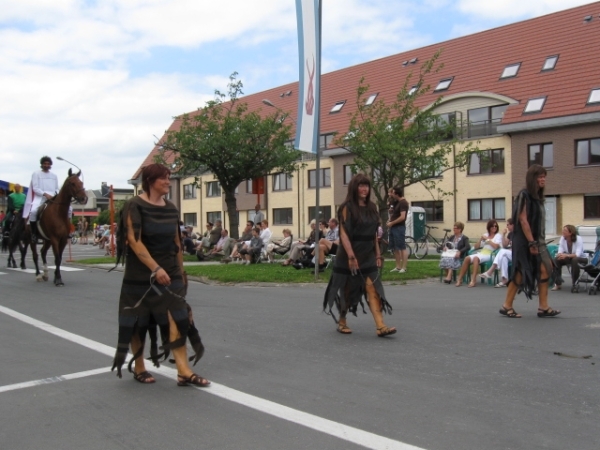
[112,164,210,387]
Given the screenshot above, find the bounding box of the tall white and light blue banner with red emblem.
[294,0,321,153]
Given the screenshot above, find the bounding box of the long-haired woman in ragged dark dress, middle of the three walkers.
[323,174,396,337]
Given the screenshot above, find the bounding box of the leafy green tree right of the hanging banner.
[336,51,479,224]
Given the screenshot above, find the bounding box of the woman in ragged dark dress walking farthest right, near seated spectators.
[499,164,560,319]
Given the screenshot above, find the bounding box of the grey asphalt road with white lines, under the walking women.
[0,246,600,450]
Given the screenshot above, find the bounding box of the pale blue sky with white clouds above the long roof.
[0,0,590,189]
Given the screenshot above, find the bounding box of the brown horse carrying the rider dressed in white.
[25,169,87,286]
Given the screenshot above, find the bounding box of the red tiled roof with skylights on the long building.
[134,2,600,178]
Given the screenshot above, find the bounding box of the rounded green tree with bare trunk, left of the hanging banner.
[158,72,299,238]
